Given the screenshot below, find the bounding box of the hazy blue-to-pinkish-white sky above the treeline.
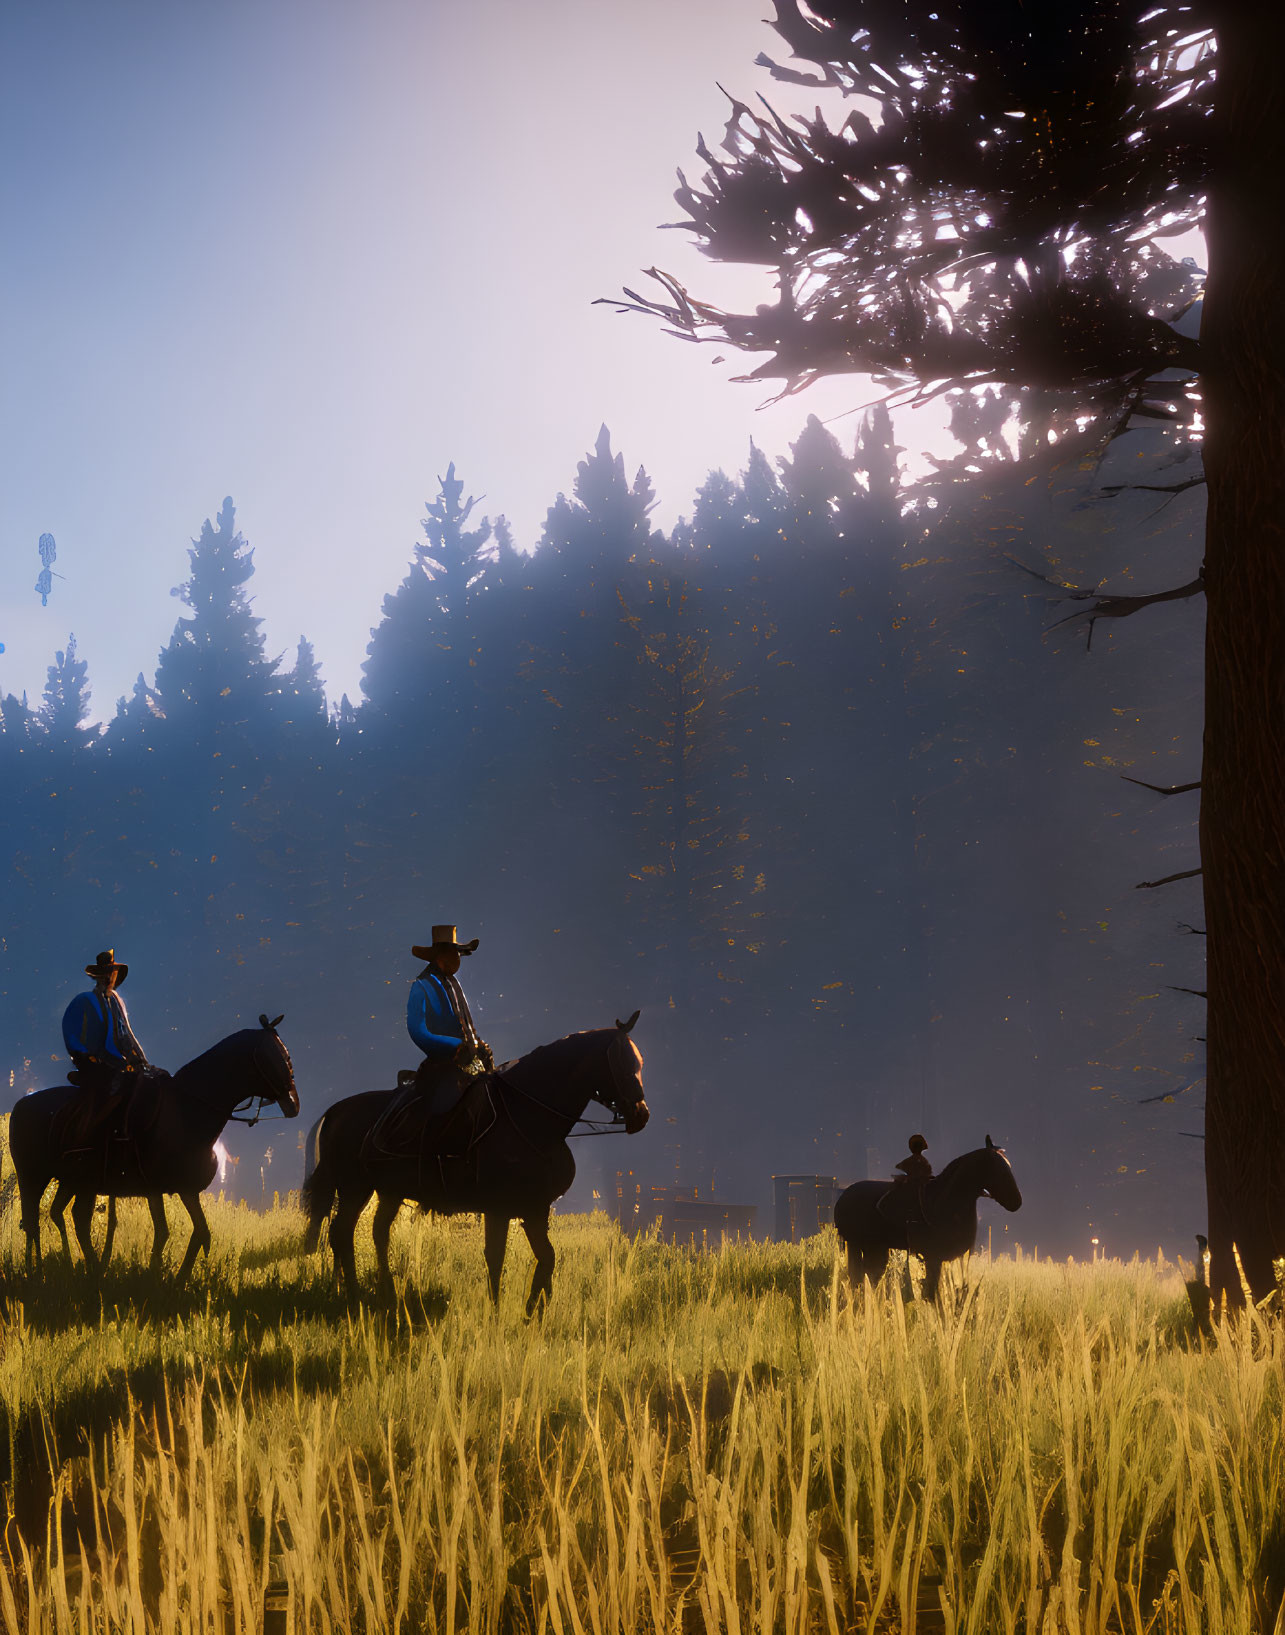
[0,0,871,718]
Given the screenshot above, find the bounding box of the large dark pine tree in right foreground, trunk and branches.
[611,0,1285,1301]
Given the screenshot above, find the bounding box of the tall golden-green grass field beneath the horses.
[0,1177,1285,1635]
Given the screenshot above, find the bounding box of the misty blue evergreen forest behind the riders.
[0,408,1205,1256]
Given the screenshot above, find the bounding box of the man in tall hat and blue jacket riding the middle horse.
[363,925,495,1161]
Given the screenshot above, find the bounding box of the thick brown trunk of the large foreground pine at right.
[1200,0,1285,1303]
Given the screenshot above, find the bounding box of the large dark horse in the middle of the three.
[302,1010,649,1316]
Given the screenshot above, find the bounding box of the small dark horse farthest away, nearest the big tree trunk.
[834,1135,1022,1300]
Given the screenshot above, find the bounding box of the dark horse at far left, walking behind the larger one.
[8,1015,299,1283]
